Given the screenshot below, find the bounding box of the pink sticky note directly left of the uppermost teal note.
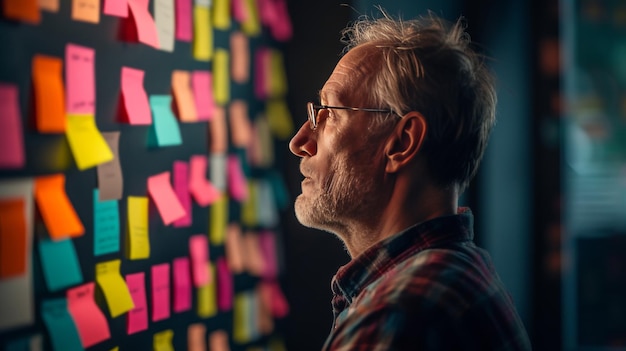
[121,67,152,125]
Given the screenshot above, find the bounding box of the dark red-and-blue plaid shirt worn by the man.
[323,208,531,351]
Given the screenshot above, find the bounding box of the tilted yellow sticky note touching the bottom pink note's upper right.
[96,259,135,318]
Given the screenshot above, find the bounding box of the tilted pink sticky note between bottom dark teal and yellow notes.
[67,282,111,348]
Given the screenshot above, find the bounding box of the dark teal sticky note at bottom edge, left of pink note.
[41,298,84,351]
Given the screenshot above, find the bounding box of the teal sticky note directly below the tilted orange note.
[39,239,83,291]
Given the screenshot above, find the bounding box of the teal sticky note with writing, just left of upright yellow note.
[93,189,120,256]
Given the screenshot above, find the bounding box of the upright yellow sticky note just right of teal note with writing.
[127,196,150,260]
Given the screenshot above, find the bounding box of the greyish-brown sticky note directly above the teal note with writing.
[97,132,124,201]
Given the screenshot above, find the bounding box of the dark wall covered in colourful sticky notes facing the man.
[0,0,294,351]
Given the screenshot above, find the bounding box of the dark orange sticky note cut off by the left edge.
[0,198,26,279]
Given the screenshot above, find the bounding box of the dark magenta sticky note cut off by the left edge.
[0,83,26,168]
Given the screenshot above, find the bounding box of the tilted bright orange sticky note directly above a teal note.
[35,173,85,240]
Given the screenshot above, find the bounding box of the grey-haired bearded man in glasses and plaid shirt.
[289,12,530,351]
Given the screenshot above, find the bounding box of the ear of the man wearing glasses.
[385,111,427,173]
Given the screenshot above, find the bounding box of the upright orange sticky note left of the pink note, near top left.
[32,55,66,133]
